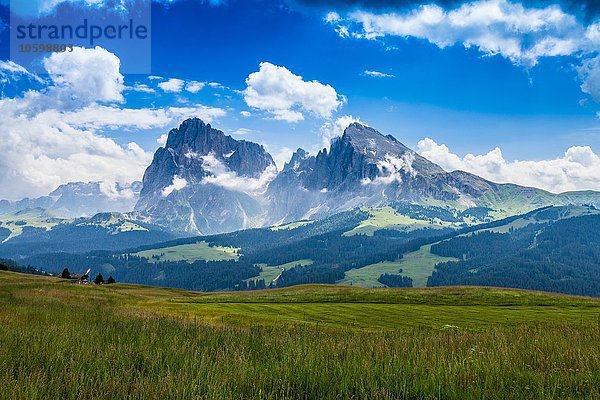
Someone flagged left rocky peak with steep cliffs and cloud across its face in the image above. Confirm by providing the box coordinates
[136,118,275,234]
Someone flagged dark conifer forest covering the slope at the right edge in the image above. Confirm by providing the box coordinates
[428,215,600,296]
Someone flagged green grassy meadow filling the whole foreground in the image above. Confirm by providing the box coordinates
[0,272,600,399]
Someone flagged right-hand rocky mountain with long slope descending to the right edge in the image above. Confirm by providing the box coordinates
[268,123,600,222]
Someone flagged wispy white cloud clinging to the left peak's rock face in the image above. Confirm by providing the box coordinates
[200,154,277,195]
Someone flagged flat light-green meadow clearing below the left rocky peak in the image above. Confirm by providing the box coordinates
[134,242,240,263]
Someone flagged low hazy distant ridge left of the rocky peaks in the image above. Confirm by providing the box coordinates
[0,182,142,218]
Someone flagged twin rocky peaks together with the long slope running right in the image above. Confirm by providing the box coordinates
[134,118,600,234]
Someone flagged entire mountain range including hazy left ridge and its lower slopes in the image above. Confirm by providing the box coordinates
[0,118,600,258]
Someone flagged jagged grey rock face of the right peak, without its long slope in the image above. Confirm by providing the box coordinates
[269,123,468,222]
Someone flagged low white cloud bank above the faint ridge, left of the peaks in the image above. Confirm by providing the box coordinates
[0,95,152,200]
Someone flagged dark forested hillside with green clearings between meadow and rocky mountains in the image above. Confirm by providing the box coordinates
[22,203,600,296]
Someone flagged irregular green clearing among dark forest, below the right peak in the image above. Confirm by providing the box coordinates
[336,245,456,288]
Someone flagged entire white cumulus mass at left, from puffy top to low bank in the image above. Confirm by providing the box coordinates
[0,48,225,200]
